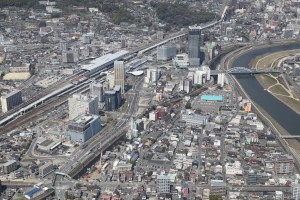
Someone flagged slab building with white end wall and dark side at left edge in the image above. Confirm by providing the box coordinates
[1,90,22,113]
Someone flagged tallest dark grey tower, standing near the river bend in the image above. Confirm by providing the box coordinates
[189,26,201,67]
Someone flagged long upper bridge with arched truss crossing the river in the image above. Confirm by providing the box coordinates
[211,67,281,75]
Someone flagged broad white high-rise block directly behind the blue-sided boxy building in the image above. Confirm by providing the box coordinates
[68,94,99,120]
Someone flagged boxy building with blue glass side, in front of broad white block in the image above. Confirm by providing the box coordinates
[68,114,101,143]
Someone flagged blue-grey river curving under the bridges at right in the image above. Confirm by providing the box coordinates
[232,43,300,135]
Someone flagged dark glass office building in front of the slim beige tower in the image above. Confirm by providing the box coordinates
[104,85,122,111]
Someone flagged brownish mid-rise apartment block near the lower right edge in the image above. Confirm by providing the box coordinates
[274,155,294,174]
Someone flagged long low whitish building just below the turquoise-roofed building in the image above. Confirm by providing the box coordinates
[181,110,208,126]
